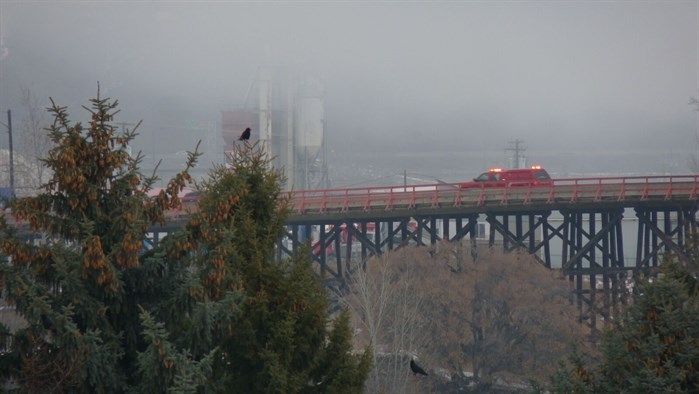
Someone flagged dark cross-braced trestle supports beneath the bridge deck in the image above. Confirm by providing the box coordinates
[280,204,697,332]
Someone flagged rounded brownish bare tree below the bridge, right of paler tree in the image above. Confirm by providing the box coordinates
[431,245,587,382]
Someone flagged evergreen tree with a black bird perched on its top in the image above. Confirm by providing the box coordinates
[143,144,370,393]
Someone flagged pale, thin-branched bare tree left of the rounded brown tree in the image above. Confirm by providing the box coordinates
[344,249,430,393]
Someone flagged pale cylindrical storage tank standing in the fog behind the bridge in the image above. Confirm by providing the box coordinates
[294,78,325,160]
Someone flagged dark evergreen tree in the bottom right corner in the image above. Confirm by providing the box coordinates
[551,255,699,393]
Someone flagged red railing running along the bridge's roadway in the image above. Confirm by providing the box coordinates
[291,175,699,214]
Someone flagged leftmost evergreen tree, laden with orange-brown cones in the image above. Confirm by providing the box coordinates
[0,89,196,393]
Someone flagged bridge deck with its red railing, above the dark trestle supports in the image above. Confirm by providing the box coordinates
[290,175,699,222]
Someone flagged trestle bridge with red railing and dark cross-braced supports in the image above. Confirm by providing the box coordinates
[277,175,699,329]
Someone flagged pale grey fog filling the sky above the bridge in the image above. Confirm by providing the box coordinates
[0,0,699,185]
